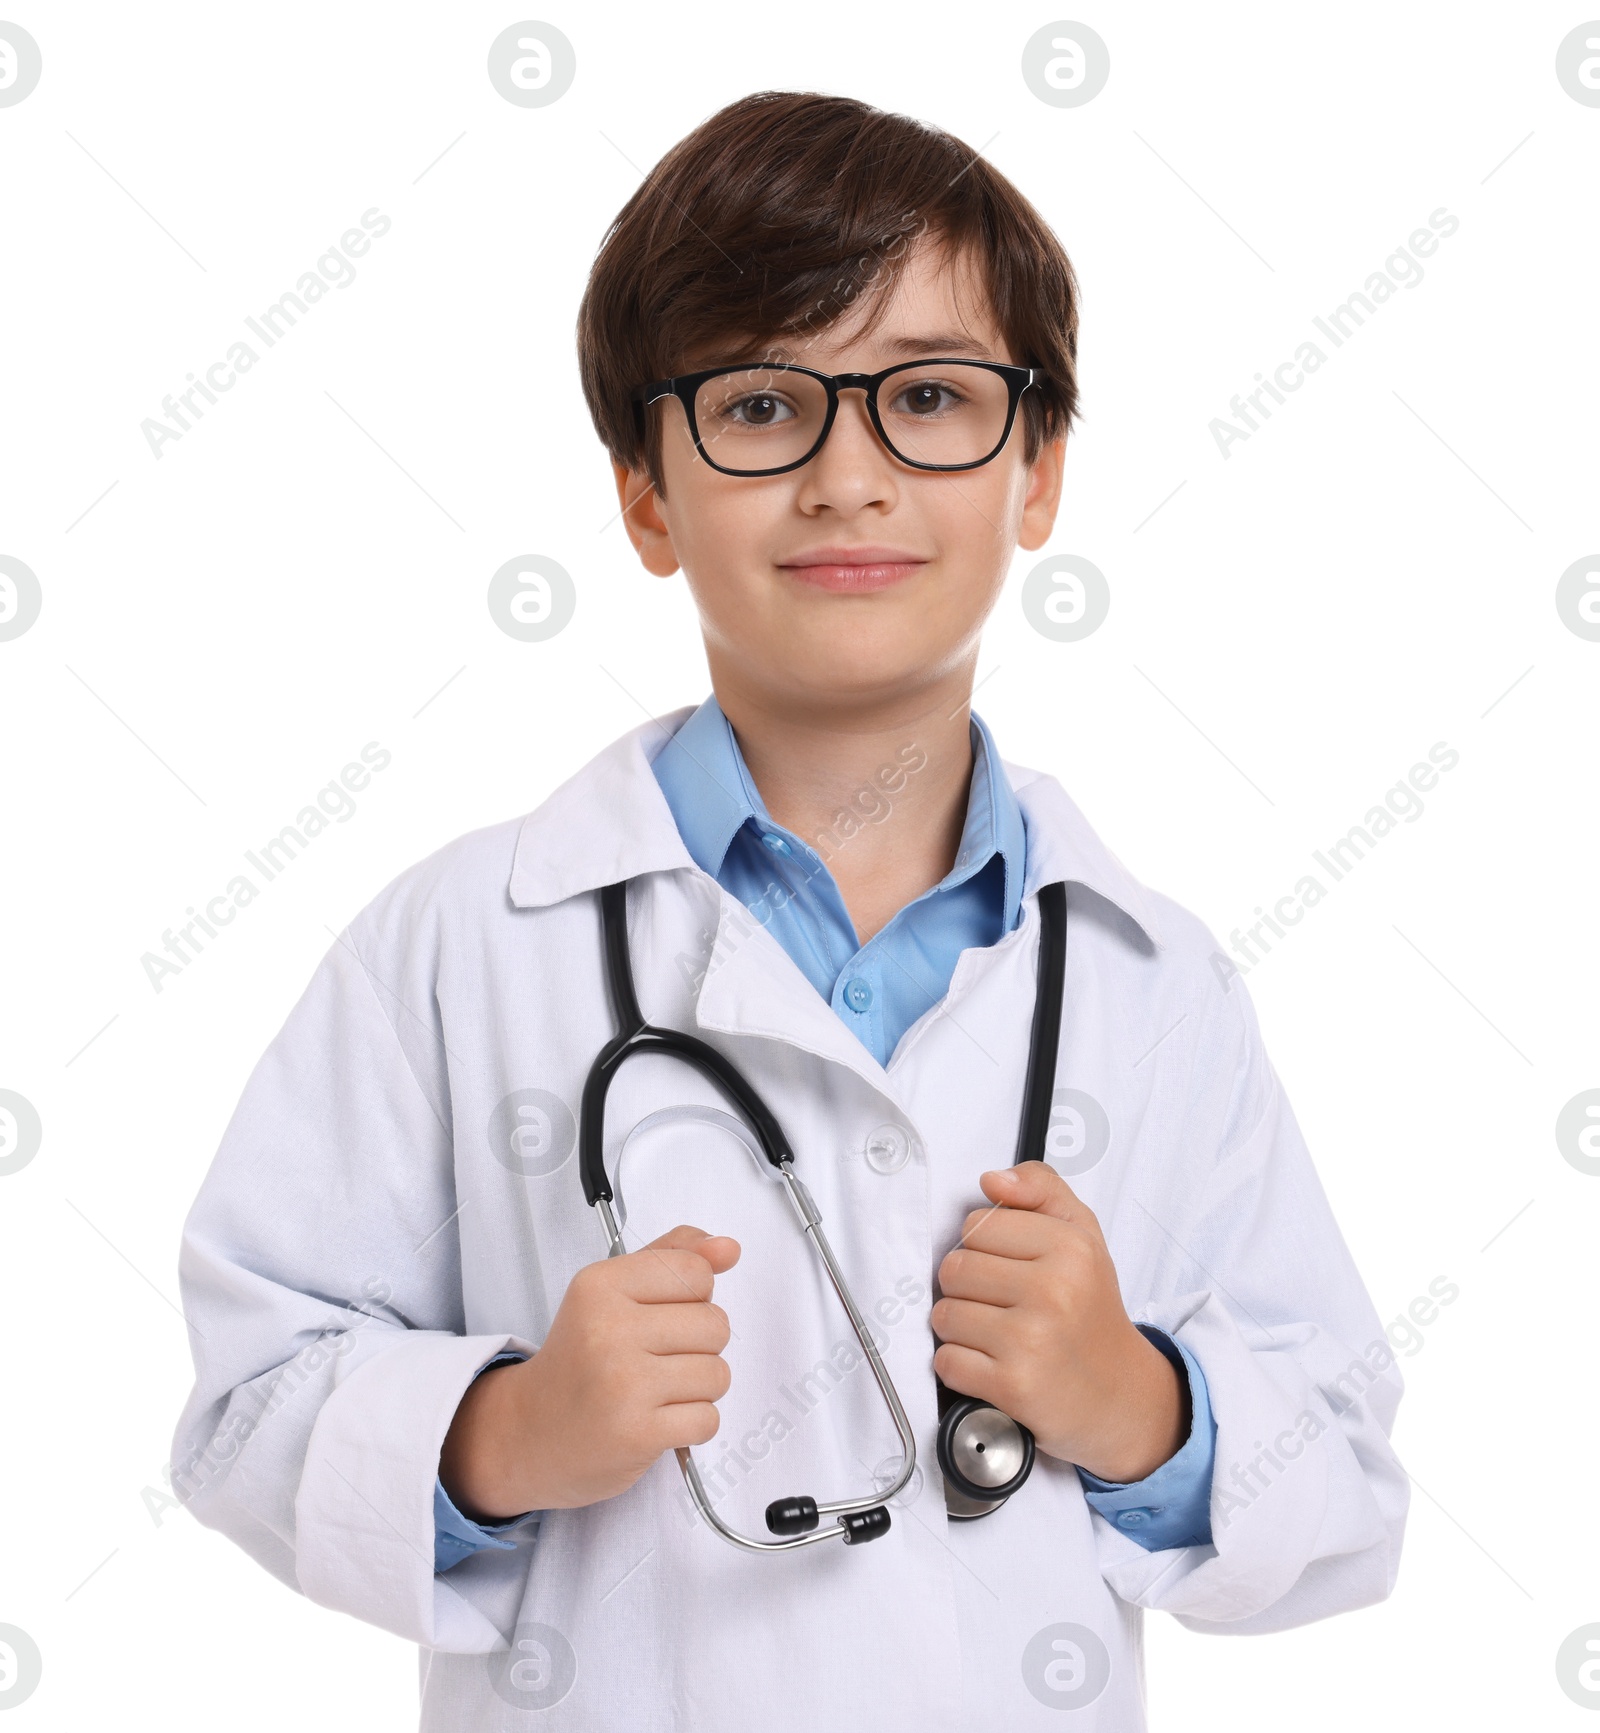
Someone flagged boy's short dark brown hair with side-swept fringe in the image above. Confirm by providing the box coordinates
[577,90,1078,489]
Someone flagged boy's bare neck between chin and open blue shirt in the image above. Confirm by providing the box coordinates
[712,662,972,944]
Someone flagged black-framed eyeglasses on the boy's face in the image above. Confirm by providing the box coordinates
[633,357,1044,475]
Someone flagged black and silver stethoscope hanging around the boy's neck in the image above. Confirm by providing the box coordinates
[577,879,1066,1553]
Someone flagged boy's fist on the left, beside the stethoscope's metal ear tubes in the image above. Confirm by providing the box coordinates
[439,1227,738,1522]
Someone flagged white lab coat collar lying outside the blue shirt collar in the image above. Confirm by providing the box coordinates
[506,700,1163,944]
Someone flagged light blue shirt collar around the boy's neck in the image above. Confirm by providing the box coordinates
[650,695,1026,932]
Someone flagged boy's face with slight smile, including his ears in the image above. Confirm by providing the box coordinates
[617,239,1064,712]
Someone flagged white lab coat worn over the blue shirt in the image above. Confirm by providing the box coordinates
[173,711,1408,1733]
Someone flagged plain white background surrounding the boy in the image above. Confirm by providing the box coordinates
[0,0,1600,1733]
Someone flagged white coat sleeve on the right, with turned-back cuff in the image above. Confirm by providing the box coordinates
[1094,981,1409,1634]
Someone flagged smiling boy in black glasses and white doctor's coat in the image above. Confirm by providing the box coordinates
[175,94,1406,1733]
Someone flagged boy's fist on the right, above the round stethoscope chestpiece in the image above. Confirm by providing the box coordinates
[931,1161,1189,1482]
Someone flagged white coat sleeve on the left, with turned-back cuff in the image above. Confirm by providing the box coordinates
[173,910,536,1650]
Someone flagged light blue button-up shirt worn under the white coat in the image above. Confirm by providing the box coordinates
[433,697,1217,1570]
